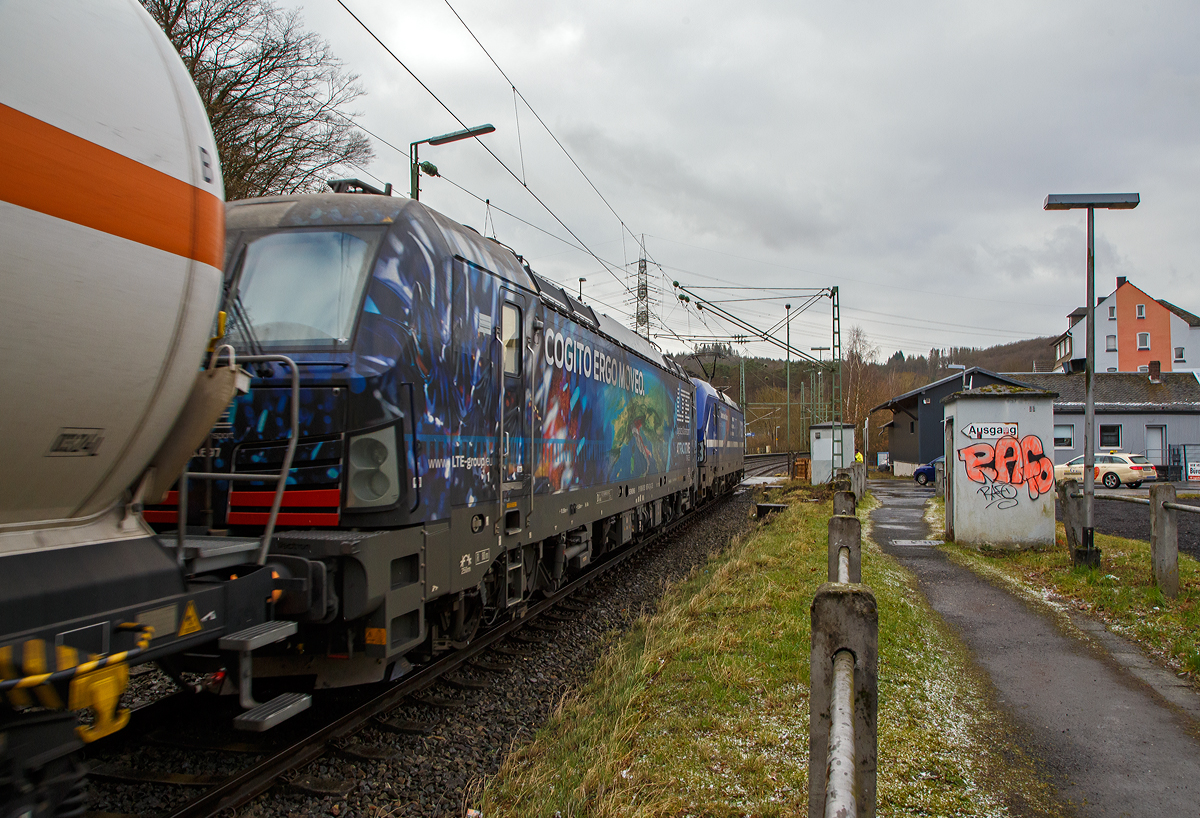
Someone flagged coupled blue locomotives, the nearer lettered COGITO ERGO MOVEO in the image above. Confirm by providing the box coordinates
[148,189,742,687]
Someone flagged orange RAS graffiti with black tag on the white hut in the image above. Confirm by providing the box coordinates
[959,434,1054,509]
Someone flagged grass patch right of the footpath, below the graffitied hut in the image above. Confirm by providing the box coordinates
[928,501,1200,684]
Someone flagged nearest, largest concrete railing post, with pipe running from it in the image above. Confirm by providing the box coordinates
[809,583,880,818]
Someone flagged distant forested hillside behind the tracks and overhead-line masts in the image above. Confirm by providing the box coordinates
[673,326,1054,452]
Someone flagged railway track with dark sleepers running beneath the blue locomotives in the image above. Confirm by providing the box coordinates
[84,486,753,818]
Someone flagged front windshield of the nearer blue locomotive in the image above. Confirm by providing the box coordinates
[230,227,385,349]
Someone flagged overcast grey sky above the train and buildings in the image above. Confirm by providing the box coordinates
[284,0,1200,357]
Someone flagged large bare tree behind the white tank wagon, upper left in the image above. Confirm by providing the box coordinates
[142,0,373,199]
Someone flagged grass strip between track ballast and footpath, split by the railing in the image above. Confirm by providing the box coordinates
[474,487,1057,818]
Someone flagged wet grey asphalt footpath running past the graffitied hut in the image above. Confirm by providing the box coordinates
[869,480,1200,818]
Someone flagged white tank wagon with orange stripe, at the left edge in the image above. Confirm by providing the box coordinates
[0,0,294,816]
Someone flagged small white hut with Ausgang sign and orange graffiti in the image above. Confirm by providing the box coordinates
[942,384,1056,549]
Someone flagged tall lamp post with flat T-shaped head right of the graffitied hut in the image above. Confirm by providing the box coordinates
[1042,193,1141,567]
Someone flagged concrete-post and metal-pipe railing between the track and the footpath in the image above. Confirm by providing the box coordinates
[809,475,878,818]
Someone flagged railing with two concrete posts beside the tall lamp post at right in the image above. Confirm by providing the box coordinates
[1058,480,1200,597]
